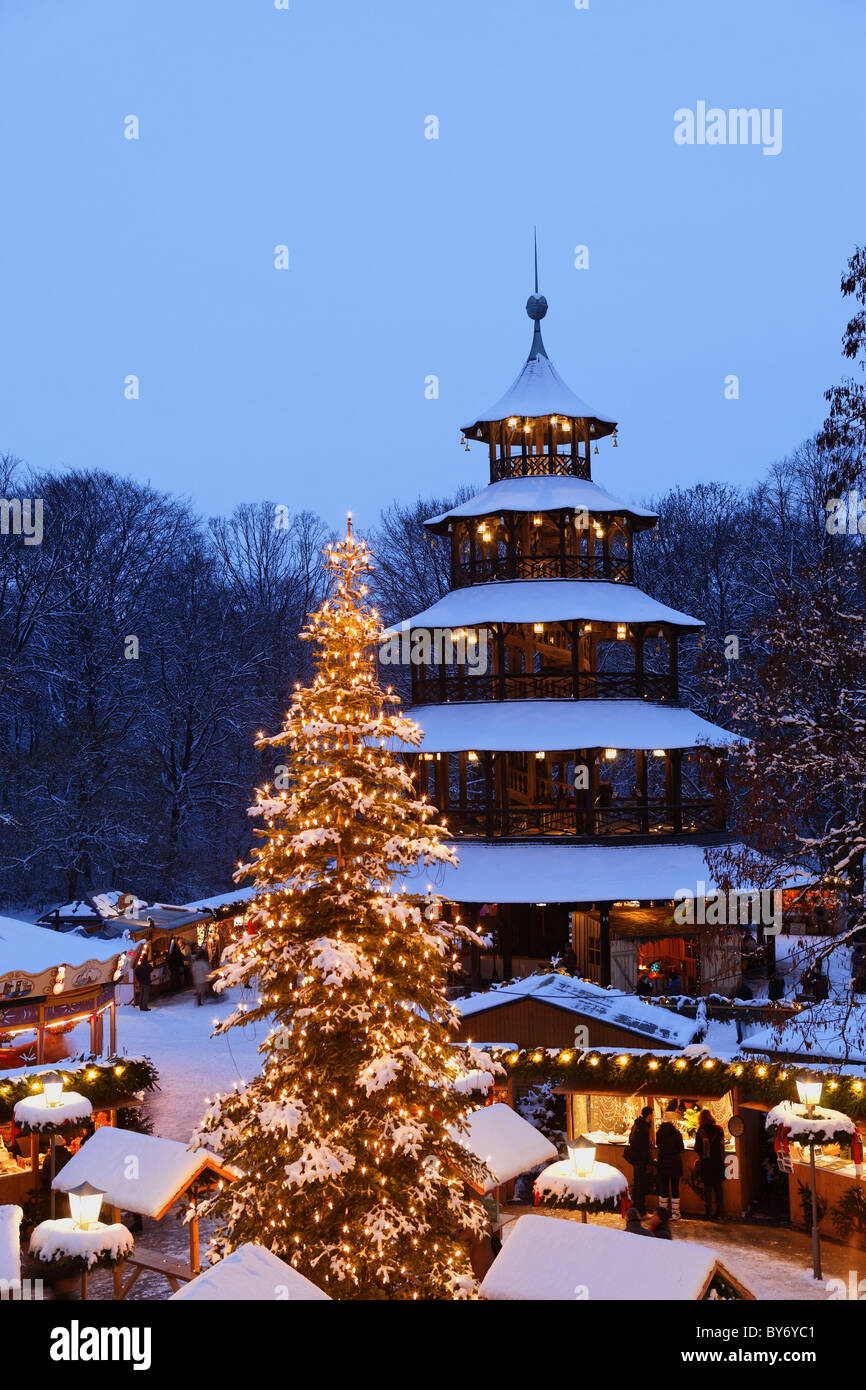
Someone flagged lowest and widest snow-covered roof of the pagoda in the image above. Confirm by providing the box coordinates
[399,841,753,902]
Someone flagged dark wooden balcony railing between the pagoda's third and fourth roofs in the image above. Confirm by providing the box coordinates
[411,667,677,705]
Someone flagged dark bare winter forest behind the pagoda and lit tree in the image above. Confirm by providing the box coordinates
[0,441,865,908]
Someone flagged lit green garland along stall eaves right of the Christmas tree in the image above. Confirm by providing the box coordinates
[488,1048,866,1120]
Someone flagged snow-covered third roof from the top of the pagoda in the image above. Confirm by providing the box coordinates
[389,580,703,632]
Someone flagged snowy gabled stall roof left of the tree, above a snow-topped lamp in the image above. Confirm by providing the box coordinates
[51,1125,235,1220]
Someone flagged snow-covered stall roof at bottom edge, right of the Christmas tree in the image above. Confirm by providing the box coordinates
[481,1216,749,1305]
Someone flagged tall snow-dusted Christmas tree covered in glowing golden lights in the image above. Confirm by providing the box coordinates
[195,531,494,1300]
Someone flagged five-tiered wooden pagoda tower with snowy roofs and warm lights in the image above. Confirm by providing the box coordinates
[402,271,740,992]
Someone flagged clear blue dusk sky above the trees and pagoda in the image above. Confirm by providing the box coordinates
[0,0,866,524]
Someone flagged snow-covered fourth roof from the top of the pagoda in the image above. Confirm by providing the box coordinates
[398,700,738,753]
